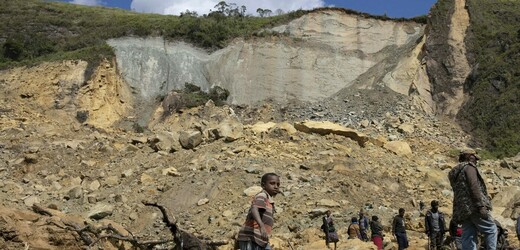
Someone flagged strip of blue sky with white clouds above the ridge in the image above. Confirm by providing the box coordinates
[51,0,437,18]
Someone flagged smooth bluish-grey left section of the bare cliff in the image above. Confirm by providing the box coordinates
[108,38,209,99]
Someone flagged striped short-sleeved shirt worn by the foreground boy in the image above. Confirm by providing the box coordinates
[237,191,274,247]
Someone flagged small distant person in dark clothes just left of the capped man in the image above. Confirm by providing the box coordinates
[424,200,446,250]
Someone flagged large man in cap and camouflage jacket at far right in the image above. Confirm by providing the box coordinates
[448,149,498,250]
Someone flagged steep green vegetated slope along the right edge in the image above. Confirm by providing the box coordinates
[460,0,520,157]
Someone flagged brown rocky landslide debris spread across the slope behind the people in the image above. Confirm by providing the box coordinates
[0,62,520,249]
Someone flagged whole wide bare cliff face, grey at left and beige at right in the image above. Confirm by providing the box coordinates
[109,10,431,112]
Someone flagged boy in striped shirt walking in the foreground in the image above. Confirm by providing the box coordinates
[237,173,280,250]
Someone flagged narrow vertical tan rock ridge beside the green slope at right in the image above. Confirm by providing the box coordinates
[426,0,471,117]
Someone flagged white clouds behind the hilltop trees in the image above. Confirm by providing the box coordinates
[130,0,325,15]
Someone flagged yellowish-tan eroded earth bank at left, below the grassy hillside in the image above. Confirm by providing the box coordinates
[0,61,133,129]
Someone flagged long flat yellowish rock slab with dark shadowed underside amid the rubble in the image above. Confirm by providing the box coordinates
[294,121,369,147]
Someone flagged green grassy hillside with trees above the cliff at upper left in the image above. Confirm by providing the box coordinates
[0,0,425,69]
